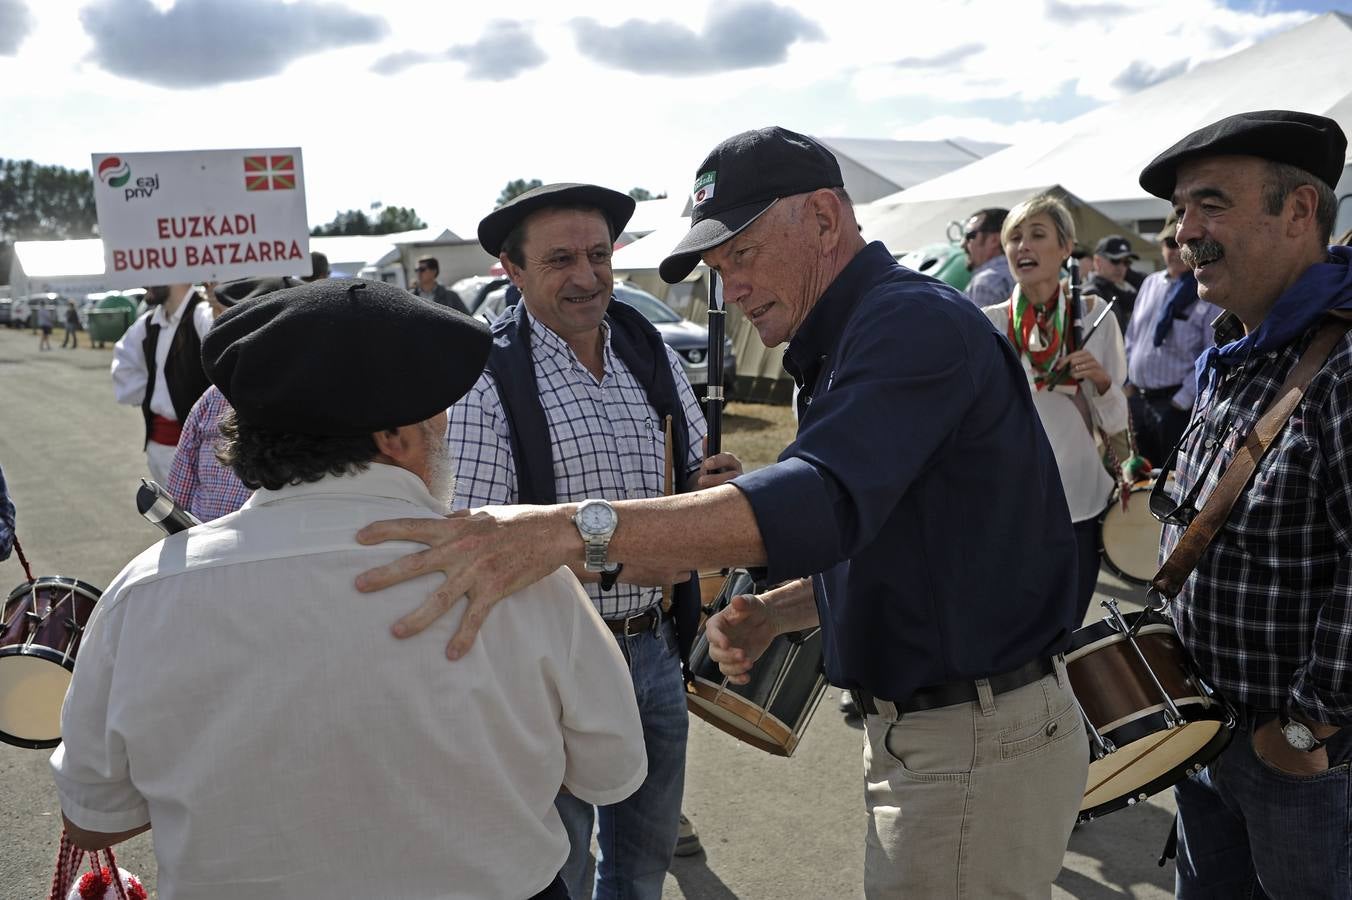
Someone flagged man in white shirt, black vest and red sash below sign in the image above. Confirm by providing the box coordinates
[112,284,212,484]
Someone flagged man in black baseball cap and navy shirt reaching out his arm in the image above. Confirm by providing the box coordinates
[358,128,1088,897]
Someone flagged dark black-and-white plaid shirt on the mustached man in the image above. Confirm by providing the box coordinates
[1161,322,1352,724]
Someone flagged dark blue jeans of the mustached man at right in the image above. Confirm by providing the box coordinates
[1174,714,1352,900]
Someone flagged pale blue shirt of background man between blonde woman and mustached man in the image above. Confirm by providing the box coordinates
[1126,272,1221,409]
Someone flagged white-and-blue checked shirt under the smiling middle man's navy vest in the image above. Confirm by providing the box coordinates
[446,314,704,619]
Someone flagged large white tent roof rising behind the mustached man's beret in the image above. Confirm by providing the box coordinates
[876,12,1352,229]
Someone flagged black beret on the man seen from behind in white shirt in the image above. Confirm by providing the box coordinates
[201,278,491,438]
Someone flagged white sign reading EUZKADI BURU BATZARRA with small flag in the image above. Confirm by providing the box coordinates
[93,147,310,288]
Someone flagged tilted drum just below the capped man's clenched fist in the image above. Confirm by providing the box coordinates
[685,569,826,757]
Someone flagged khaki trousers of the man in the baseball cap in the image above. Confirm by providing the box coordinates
[864,657,1090,900]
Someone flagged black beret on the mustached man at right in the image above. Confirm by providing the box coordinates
[1141,109,1348,200]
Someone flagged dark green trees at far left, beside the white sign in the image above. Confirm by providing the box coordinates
[0,159,99,284]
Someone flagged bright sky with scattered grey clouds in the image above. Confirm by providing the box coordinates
[0,0,1352,235]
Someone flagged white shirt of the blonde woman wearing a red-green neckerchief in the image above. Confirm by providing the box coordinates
[982,297,1130,522]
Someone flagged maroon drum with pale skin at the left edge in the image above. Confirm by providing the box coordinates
[0,576,101,749]
